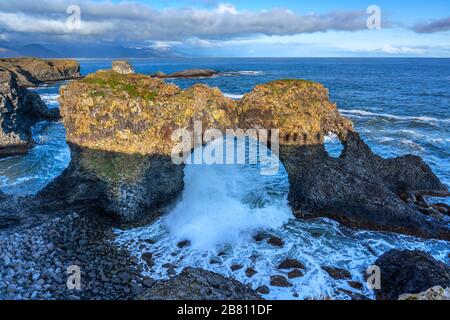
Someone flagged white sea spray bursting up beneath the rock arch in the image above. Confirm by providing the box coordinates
[163,140,292,249]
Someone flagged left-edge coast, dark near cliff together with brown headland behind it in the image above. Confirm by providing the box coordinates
[0,58,80,158]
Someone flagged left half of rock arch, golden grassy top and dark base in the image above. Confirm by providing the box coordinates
[49,71,235,221]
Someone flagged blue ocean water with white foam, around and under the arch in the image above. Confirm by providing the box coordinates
[0,59,450,299]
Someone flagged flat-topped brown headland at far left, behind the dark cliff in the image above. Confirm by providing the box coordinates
[0,58,80,87]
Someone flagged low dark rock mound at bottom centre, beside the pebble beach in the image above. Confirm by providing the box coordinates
[142,268,261,300]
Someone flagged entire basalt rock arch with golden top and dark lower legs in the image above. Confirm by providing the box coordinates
[41,71,450,239]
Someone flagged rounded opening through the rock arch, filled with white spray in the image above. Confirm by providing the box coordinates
[163,135,293,249]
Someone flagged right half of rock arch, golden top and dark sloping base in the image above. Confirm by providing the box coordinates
[239,80,450,239]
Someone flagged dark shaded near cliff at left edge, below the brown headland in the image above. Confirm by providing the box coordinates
[0,67,59,157]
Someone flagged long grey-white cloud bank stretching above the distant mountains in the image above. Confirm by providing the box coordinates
[0,0,367,41]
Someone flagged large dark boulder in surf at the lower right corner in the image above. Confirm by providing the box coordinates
[375,250,450,300]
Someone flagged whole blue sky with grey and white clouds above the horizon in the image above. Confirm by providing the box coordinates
[0,0,450,57]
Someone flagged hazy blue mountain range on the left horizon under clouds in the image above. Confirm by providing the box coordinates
[0,43,181,59]
